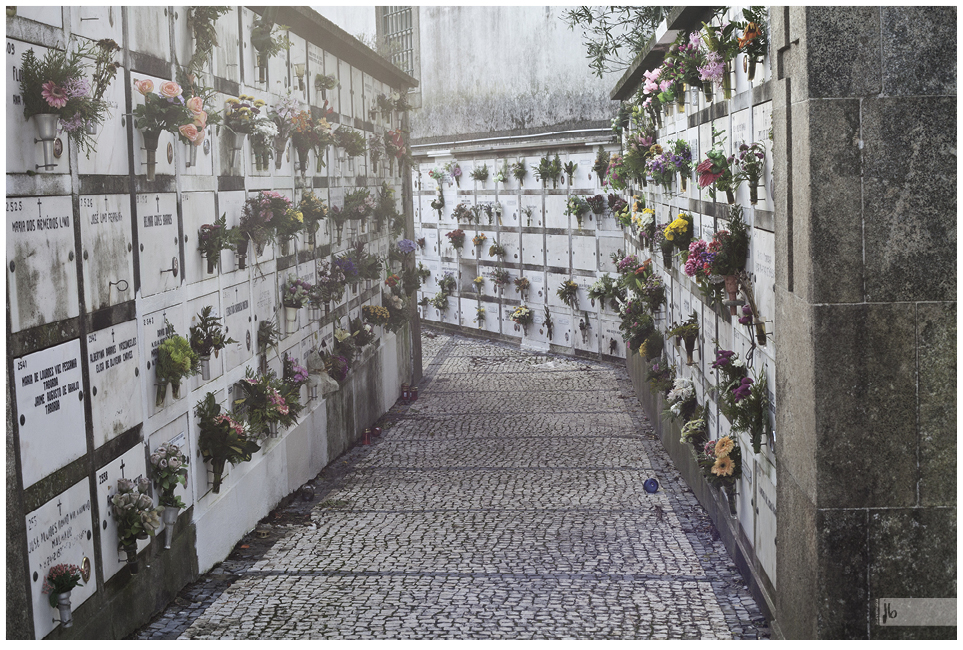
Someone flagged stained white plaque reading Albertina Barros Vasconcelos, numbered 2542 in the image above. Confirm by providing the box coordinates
[87,321,143,447]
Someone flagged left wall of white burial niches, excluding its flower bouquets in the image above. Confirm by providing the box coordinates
[6,6,420,639]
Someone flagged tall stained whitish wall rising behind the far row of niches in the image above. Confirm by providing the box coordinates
[411,6,616,142]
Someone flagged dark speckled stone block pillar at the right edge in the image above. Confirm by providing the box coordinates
[771,7,956,639]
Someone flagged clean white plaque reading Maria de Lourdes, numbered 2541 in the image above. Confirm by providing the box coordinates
[13,339,87,488]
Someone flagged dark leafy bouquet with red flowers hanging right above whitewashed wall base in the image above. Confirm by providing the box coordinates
[194,393,261,494]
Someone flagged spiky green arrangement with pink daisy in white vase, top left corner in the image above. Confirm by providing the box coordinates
[20,39,120,158]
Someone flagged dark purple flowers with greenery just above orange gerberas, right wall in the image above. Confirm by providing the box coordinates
[712,349,769,454]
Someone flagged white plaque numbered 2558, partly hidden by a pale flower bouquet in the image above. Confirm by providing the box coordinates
[97,442,153,580]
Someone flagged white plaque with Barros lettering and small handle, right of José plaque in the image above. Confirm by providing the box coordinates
[137,194,181,296]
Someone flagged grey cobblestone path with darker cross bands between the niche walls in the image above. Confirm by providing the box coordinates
[132,332,769,639]
